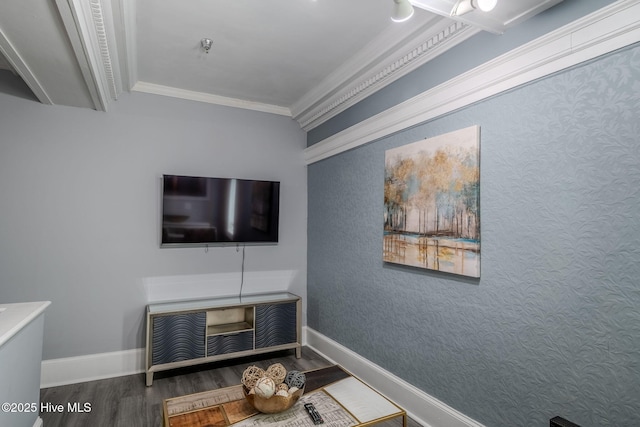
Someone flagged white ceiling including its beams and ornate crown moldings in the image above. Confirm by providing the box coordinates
[0,0,562,130]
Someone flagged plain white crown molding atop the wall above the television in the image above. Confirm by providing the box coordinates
[131,81,291,117]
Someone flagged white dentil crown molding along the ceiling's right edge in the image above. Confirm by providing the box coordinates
[292,15,481,131]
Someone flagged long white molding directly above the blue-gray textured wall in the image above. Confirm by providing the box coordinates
[304,0,640,165]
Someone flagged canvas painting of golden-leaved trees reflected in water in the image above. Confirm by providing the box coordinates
[383,126,480,277]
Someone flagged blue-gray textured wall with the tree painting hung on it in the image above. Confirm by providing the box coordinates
[307,42,640,427]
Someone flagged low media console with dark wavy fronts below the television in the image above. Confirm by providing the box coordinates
[145,292,302,386]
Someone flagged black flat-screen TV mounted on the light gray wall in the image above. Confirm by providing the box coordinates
[161,175,280,246]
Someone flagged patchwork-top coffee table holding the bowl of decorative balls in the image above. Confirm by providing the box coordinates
[162,365,407,427]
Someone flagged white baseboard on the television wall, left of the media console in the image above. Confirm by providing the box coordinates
[40,348,145,388]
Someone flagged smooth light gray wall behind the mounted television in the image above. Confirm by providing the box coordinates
[0,89,307,359]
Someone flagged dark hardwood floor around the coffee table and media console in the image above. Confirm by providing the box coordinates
[40,347,420,427]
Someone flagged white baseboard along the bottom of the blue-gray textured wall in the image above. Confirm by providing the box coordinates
[304,327,484,427]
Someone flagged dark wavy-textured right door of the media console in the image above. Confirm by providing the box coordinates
[256,302,298,348]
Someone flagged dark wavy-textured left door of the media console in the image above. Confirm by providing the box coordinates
[152,312,206,365]
